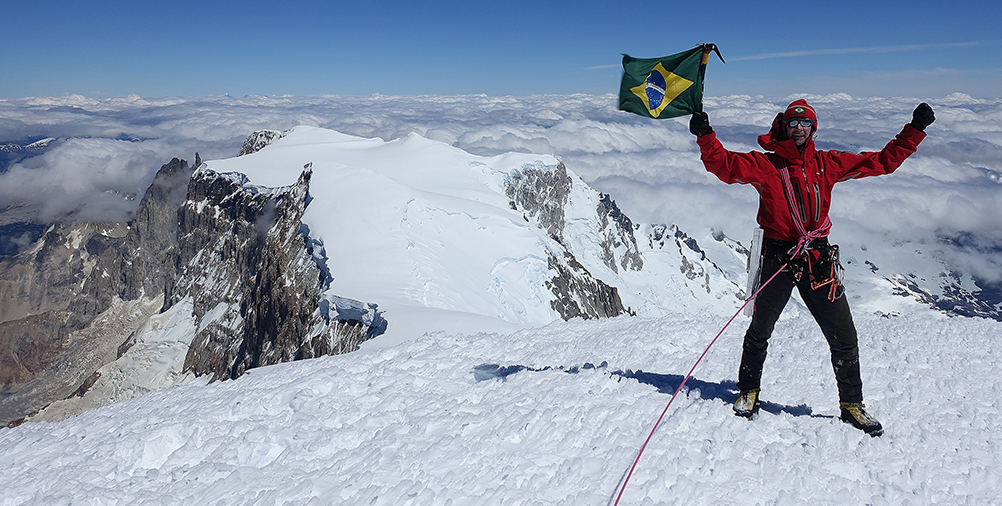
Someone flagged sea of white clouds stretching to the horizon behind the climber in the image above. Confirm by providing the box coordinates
[0,94,1002,282]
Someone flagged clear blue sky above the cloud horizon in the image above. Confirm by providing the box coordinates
[0,0,1002,98]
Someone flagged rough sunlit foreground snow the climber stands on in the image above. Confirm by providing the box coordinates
[0,308,1002,506]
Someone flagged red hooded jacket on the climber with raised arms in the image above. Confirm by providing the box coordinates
[696,117,926,241]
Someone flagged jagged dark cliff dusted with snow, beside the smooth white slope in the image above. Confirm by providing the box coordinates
[164,165,385,379]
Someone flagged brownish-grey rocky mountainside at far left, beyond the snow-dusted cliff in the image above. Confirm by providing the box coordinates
[0,154,197,424]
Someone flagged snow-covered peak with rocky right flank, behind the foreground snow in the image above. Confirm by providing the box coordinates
[205,125,737,342]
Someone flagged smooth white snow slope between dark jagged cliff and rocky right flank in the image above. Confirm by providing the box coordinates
[208,125,577,339]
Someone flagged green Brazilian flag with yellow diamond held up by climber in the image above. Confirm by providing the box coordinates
[619,45,708,119]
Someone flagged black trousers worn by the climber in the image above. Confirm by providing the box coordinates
[737,239,863,403]
